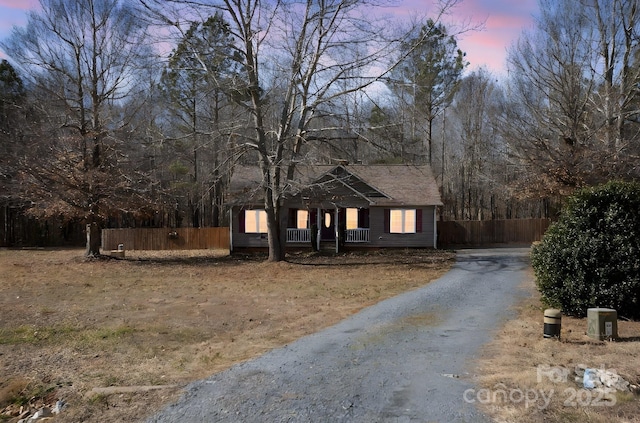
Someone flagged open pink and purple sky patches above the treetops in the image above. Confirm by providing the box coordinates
[0,0,538,75]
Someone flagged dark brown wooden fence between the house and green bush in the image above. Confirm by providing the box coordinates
[438,219,551,247]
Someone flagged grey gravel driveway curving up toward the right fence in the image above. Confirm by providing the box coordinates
[150,249,529,423]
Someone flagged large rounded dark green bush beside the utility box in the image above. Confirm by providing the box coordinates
[531,182,640,319]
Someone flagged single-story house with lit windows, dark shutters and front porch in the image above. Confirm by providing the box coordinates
[230,162,442,251]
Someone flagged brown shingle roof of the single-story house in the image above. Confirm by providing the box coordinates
[230,164,442,206]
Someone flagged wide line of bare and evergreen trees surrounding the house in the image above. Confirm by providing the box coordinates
[0,0,640,260]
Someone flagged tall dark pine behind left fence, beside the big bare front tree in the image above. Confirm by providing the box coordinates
[160,12,239,227]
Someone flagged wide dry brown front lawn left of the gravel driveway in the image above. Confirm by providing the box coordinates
[0,250,454,422]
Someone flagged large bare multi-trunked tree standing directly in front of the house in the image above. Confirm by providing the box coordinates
[141,0,454,261]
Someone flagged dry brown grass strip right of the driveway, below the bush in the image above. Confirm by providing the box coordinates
[470,275,640,423]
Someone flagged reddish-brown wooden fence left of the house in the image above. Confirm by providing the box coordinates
[102,227,229,250]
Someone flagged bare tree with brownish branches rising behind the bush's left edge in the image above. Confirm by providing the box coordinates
[501,2,596,193]
